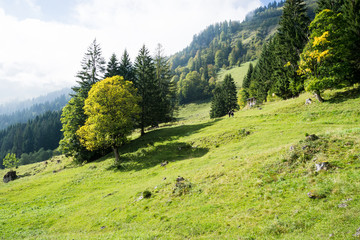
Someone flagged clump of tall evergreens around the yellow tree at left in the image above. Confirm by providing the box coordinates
[60,40,176,162]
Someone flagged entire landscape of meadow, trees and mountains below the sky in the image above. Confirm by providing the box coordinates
[0,0,360,240]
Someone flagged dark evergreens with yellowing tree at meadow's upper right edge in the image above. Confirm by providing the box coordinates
[240,0,360,106]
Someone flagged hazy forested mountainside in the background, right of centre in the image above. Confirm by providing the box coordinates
[170,1,290,104]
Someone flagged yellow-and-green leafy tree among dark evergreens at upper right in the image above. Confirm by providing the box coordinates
[298,9,350,102]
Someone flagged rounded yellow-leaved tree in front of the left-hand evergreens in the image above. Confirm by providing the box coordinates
[77,76,140,162]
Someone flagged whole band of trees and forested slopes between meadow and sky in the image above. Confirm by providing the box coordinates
[0,0,360,169]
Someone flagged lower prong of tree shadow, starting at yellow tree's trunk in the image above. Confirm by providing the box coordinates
[108,142,209,172]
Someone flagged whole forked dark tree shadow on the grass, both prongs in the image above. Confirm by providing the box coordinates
[104,119,220,171]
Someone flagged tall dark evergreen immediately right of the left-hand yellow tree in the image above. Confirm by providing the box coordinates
[134,45,161,135]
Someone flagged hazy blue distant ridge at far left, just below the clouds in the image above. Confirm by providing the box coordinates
[0,94,70,130]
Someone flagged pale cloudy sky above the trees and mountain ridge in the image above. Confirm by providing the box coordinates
[0,0,269,104]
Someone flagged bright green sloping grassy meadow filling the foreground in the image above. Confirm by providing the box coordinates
[0,85,360,239]
